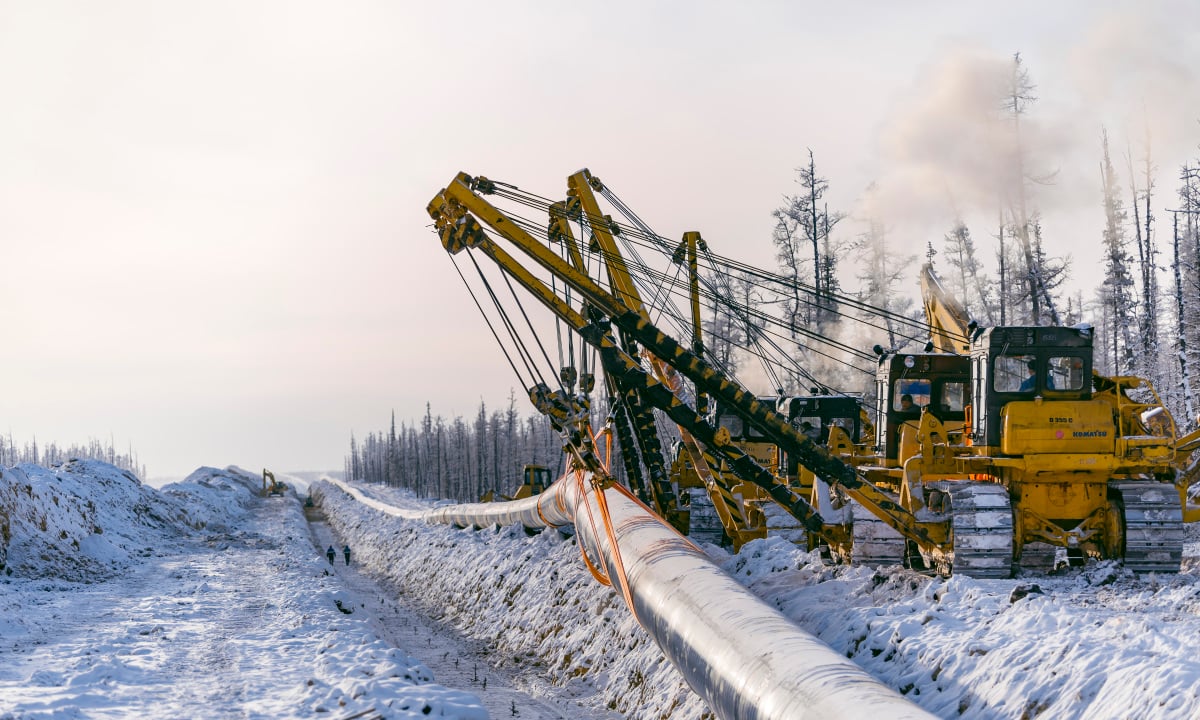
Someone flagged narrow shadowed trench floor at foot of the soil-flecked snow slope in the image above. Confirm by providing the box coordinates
[308,511,622,720]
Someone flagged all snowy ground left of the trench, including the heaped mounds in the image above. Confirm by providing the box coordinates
[0,461,487,720]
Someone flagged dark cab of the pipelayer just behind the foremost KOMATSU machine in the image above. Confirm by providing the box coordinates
[875,353,971,464]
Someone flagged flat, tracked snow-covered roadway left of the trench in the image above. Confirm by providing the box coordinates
[0,463,487,720]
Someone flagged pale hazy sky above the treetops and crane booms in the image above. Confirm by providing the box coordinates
[0,0,1200,476]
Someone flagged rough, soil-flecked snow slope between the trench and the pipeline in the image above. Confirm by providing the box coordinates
[311,482,707,718]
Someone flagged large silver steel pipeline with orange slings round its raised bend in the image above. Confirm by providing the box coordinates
[420,473,934,720]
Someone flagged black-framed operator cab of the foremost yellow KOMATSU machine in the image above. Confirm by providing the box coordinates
[970,326,1105,454]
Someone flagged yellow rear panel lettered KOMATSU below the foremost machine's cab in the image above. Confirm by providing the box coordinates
[1000,401,1116,455]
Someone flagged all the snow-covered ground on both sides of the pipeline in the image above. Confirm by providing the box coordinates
[7,461,1200,720]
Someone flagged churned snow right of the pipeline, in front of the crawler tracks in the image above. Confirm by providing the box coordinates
[725,529,1200,720]
